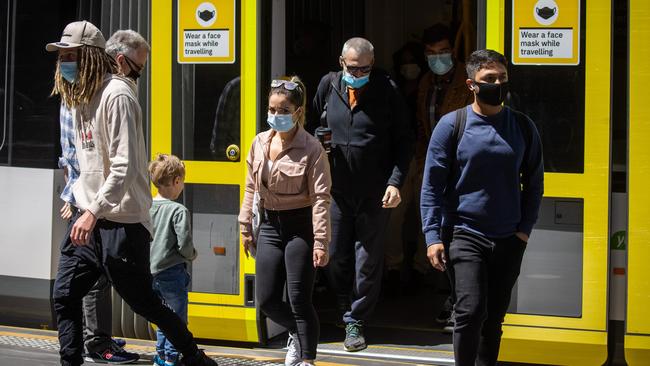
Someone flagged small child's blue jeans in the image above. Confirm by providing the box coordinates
[153,263,190,362]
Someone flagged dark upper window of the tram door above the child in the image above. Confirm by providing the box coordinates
[172,0,241,161]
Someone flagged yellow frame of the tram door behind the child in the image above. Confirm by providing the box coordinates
[150,0,259,342]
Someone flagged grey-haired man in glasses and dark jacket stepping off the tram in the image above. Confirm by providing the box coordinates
[311,38,413,351]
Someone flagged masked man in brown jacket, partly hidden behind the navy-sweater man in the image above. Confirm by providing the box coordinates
[415,23,474,329]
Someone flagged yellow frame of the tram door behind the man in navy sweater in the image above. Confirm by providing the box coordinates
[486,0,612,365]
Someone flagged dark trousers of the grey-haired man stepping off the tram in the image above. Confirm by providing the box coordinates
[327,194,390,323]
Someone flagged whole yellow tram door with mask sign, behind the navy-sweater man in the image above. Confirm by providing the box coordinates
[485,0,608,365]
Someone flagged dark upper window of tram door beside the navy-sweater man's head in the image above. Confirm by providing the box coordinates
[504,0,586,173]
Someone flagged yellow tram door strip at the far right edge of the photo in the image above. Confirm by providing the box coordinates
[624,0,650,365]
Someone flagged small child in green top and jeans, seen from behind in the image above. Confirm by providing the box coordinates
[149,154,196,366]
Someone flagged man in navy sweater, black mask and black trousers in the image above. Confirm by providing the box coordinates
[420,50,544,366]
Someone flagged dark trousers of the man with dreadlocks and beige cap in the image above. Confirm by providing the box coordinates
[53,215,198,365]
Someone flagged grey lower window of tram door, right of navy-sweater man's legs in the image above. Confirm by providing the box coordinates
[508,197,584,317]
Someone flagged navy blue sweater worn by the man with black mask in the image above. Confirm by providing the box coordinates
[420,105,544,245]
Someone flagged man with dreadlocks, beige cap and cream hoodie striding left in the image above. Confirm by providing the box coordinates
[46,21,217,366]
